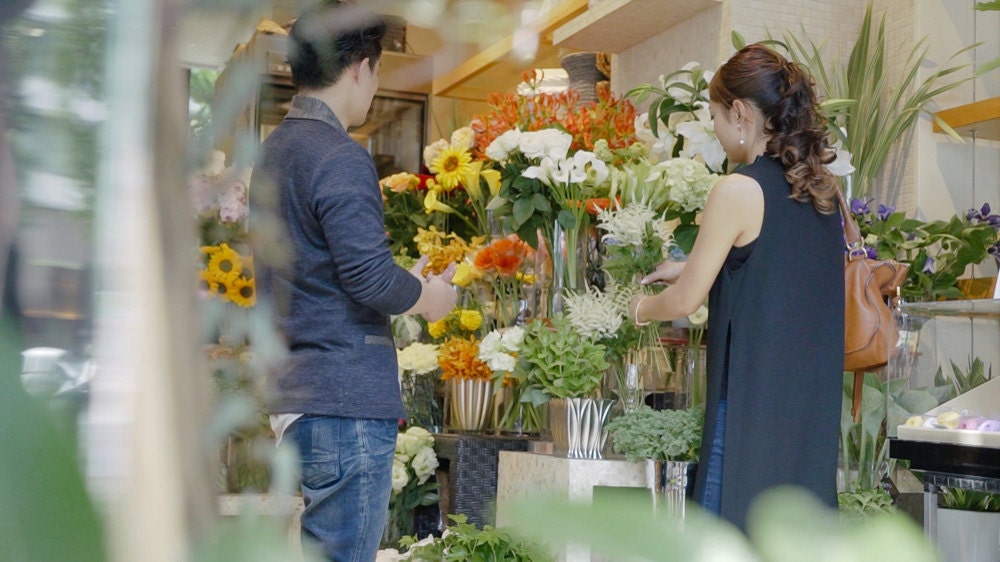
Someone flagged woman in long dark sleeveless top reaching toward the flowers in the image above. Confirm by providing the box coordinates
[629,45,844,530]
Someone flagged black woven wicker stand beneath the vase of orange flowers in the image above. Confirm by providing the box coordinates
[434,433,530,527]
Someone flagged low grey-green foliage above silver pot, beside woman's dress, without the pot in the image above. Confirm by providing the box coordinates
[604,406,705,462]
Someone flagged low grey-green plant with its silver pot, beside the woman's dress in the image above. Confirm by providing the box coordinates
[607,406,705,516]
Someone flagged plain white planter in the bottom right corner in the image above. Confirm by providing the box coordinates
[936,508,1000,562]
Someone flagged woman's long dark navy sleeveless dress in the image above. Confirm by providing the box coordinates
[695,156,844,530]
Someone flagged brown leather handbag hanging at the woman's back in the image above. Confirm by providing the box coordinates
[837,189,910,421]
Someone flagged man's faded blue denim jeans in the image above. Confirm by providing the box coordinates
[284,415,398,562]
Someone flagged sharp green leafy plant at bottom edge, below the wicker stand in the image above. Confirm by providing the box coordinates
[400,515,553,562]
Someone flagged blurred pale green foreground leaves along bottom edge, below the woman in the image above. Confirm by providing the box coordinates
[513,487,937,562]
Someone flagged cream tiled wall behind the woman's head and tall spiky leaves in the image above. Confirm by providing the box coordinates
[611,0,1000,276]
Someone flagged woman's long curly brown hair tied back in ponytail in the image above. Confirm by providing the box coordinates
[709,44,839,214]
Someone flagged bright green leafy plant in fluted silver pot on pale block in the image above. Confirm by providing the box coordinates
[514,313,614,458]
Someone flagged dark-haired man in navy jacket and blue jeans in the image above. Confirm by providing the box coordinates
[251,3,456,562]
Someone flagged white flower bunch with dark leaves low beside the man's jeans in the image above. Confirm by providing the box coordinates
[382,426,440,547]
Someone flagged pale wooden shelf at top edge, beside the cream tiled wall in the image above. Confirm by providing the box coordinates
[552,0,721,53]
